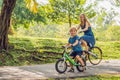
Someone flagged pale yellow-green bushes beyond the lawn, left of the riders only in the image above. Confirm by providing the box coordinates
[16,24,69,38]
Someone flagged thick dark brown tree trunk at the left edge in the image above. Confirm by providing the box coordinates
[0,0,16,50]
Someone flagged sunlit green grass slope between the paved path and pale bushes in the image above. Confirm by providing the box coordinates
[0,36,120,66]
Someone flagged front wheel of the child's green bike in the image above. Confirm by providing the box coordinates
[55,59,67,73]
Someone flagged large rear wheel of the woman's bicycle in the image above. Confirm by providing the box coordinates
[88,46,102,65]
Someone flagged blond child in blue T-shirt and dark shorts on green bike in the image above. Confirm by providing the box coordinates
[65,27,85,72]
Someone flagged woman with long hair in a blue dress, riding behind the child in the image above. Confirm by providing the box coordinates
[77,14,95,51]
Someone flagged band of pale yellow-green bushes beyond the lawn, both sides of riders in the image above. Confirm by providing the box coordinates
[16,24,120,41]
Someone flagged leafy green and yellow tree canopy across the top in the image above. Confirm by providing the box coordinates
[0,0,119,28]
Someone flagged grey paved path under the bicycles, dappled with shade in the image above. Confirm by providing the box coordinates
[0,60,120,80]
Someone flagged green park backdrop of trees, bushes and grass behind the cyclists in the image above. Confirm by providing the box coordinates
[0,0,120,79]
